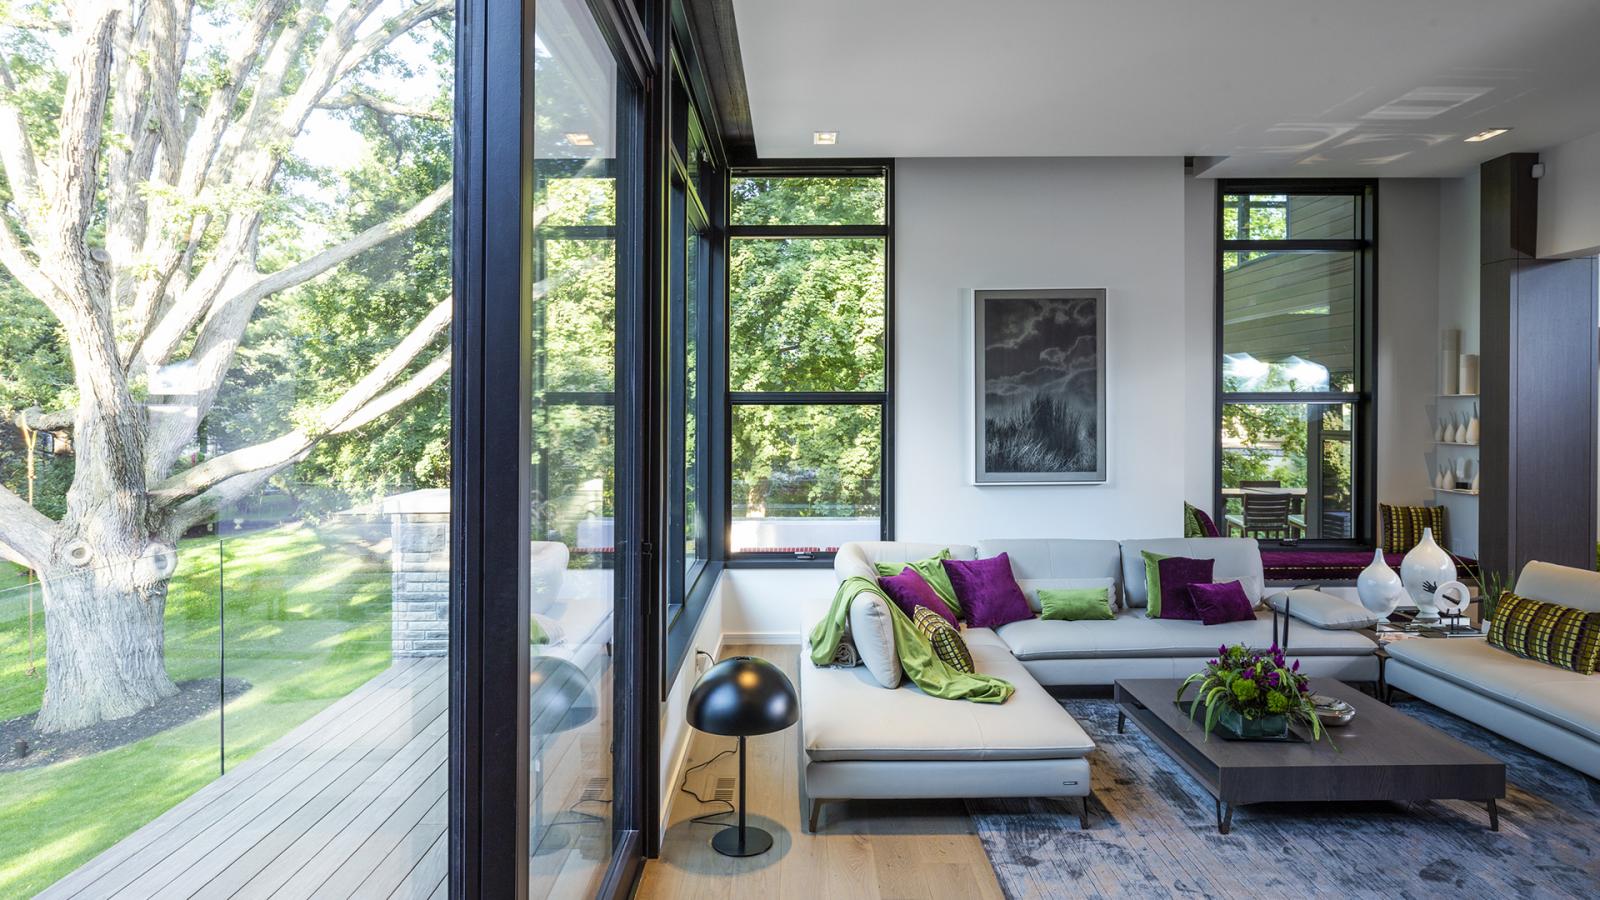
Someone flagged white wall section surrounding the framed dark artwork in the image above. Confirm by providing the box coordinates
[894,159,1187,543]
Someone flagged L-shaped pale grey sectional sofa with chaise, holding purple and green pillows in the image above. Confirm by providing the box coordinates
[800,538,1378,831]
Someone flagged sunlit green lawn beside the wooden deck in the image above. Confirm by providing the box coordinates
[0,525,390,897]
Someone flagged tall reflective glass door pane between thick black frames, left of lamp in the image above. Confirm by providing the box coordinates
[528,0,651,897]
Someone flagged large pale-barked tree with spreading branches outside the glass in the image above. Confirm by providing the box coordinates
[0,0,453,732]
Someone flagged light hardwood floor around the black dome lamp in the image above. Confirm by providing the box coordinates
[637,644,1002,900]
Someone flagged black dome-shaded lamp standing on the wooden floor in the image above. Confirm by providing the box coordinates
[688,657,800,857]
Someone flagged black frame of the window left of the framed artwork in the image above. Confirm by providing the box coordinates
[718,159,894,569]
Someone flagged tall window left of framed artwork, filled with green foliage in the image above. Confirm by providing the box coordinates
[728,165,893,559]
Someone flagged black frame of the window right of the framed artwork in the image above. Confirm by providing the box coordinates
[1211,178,1378,549]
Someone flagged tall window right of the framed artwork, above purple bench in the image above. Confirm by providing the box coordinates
[1218,181,1376,541]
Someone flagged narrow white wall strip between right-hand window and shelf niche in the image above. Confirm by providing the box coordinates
[1376,178,1440,506]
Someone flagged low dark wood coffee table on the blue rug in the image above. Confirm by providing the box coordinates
[1115,679,1506,834]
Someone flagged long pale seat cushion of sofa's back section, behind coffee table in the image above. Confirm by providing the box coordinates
[995,602,1376,660]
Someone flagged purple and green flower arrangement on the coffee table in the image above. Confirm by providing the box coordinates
[1178,644,1323,741]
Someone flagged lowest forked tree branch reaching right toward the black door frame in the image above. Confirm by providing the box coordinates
[150,298,451,509]
